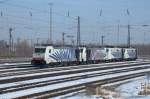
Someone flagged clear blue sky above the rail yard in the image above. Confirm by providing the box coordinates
[0,0,150,44]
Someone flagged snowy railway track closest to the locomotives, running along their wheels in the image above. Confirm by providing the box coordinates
[0,61,150,77]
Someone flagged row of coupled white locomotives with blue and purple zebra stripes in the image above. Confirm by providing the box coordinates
[31,46,137,65]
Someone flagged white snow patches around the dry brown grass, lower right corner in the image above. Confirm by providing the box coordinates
[55,76,150,99]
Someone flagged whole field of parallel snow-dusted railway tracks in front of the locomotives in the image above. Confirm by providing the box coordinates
[0,59,150,99]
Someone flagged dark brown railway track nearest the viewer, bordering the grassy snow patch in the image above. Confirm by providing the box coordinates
[34,73,144,99]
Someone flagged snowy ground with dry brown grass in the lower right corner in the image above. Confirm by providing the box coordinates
[60,76,150,99]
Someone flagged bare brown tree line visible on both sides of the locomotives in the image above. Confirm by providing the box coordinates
[0,40,150,58]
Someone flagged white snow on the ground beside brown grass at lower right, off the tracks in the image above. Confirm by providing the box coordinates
[57,76,150,99]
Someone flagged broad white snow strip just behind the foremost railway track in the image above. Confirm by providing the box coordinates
[0,65,150,99]
